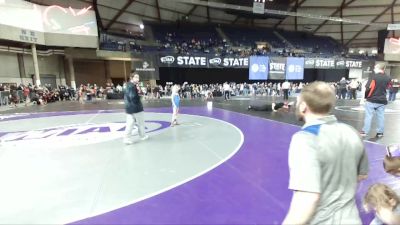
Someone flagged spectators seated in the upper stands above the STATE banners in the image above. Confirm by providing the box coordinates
[100,26,360,58]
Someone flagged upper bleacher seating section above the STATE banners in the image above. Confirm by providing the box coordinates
[100,23,344,57]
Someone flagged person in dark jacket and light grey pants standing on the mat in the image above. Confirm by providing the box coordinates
[124,74,148,144]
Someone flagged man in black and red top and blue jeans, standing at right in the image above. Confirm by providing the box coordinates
[360,63,390,138]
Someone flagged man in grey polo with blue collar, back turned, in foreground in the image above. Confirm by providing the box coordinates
[283,82,368,224]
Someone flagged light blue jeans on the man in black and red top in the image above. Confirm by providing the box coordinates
[362,101,385,134]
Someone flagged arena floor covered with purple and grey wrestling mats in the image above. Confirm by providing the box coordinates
[0,97,400,224]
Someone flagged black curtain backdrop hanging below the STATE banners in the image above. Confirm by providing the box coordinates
[158,67,349,85]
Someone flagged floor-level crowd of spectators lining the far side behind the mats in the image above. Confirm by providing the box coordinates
[0,78,399,107]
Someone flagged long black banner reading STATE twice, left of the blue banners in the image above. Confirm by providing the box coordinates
[158,54,249,68]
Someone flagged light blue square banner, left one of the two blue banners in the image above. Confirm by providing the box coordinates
[249,56,269,80]
